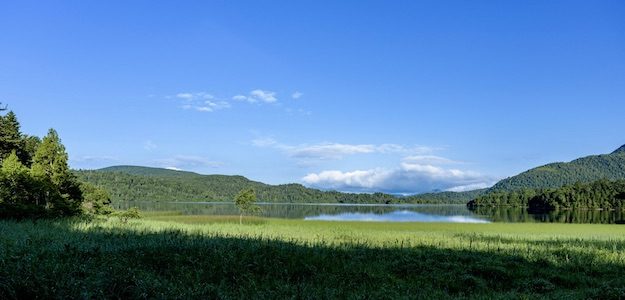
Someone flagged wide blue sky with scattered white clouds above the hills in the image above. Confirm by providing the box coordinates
[0,1,625,193]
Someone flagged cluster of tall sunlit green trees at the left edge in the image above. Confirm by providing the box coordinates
[0,106,110,219]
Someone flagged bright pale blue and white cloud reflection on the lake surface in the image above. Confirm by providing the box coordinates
[304,210,490,223]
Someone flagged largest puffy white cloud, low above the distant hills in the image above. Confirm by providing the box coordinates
[302,157,496,194]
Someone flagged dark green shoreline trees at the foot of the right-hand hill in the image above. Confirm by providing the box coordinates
[467,179,625,212]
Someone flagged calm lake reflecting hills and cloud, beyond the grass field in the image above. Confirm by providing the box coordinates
[114,202,625,224]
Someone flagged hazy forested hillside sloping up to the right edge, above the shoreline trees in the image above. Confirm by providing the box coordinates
[489,145,625,192]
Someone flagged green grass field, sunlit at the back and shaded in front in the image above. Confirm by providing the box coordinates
[0,213,625,299]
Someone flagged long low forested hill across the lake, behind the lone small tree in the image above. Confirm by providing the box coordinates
[75,166,481,204]
